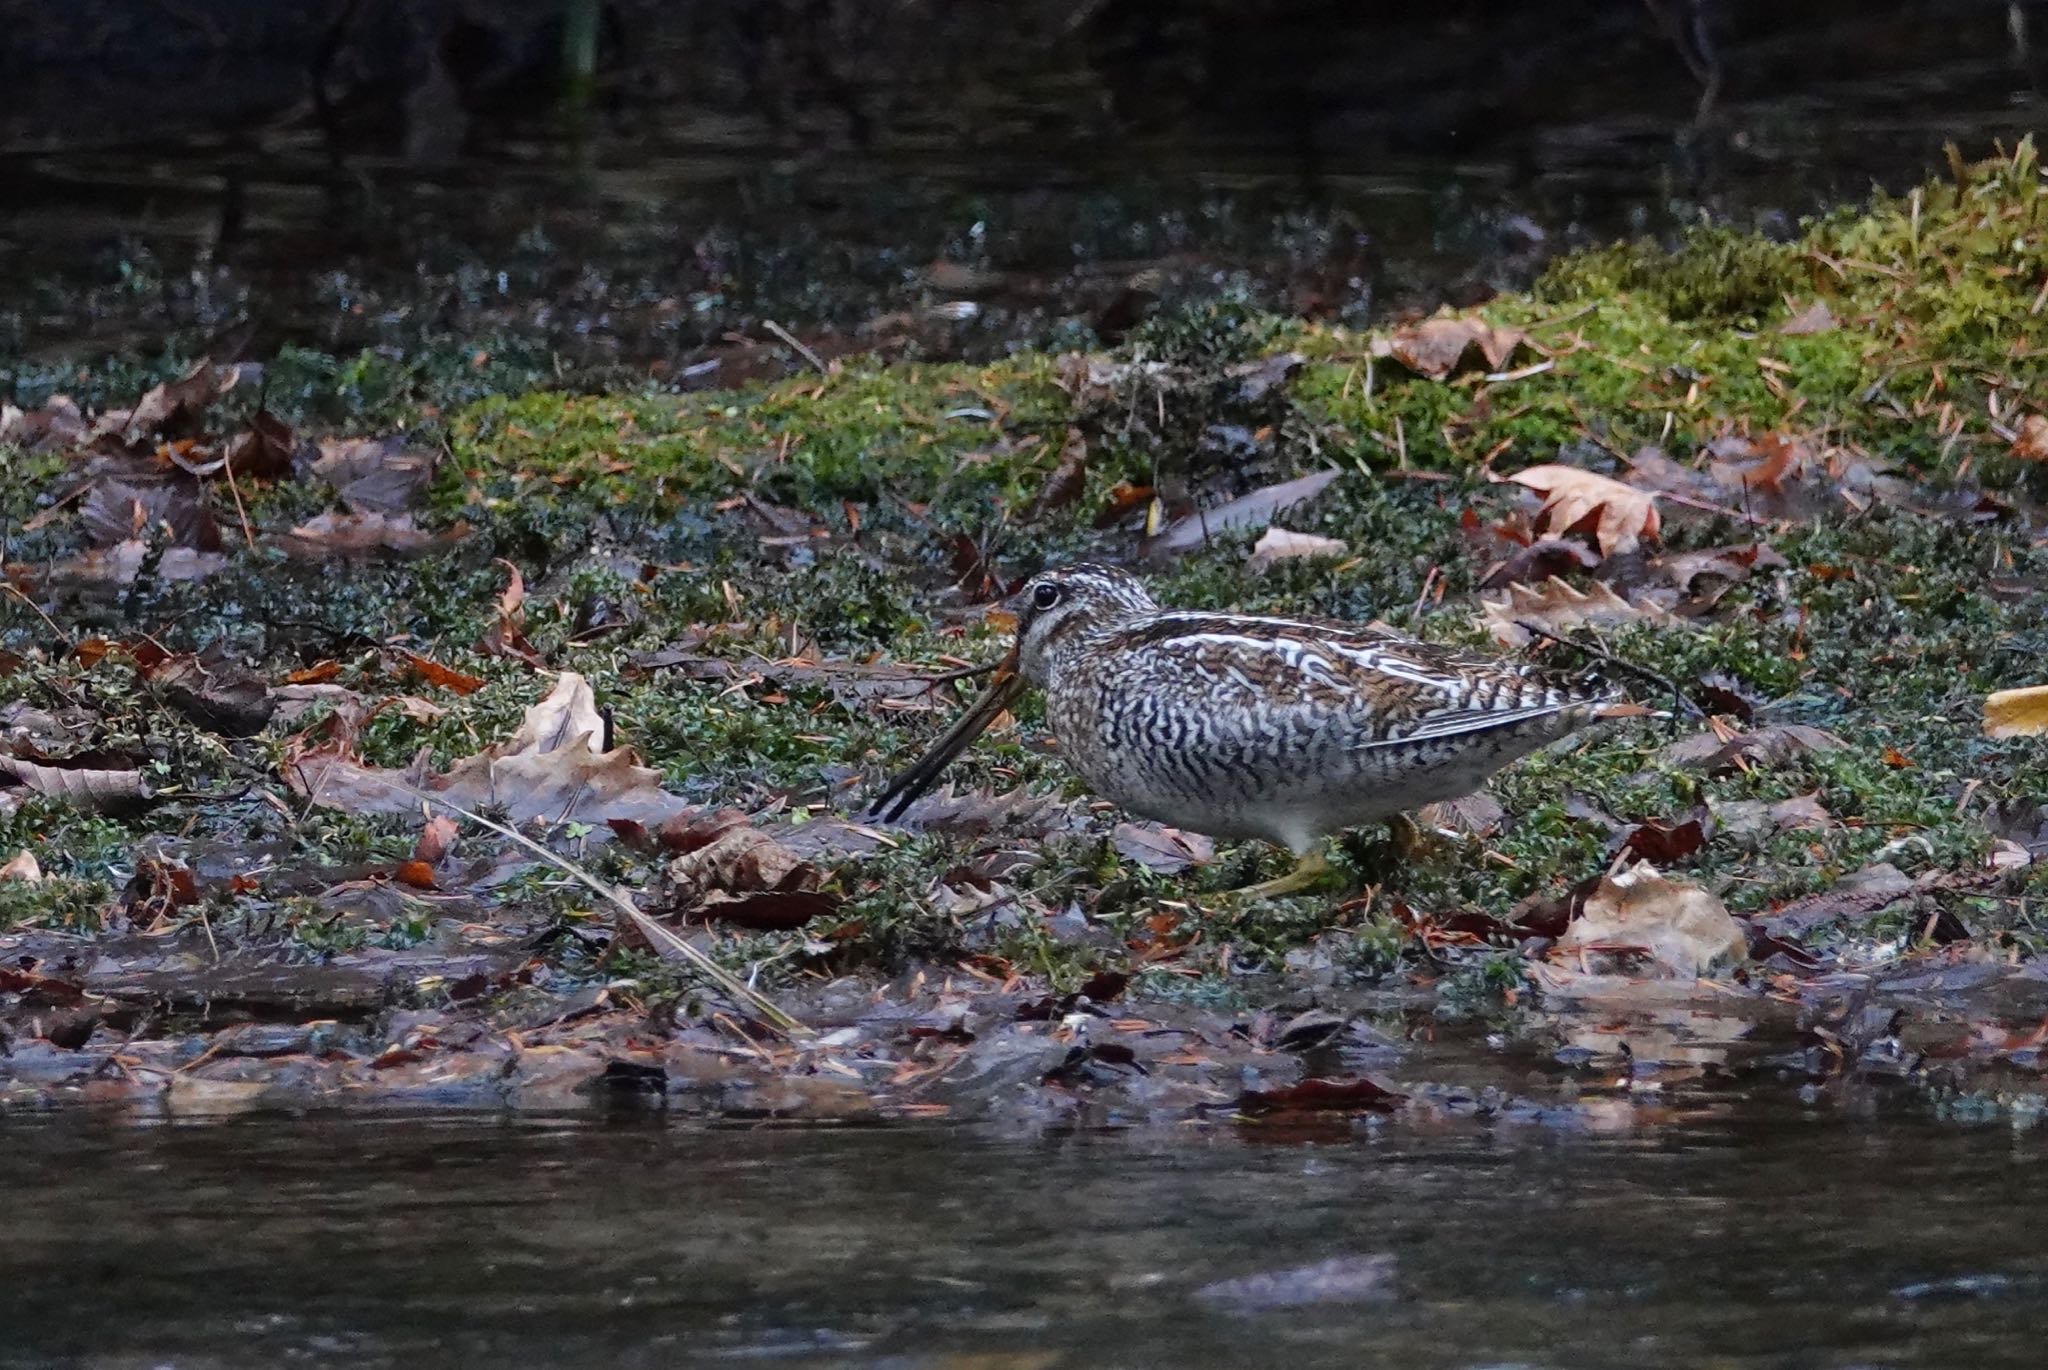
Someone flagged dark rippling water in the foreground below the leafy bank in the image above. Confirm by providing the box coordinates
[0,1108,2048,1370]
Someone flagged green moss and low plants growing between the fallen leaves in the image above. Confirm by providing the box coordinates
[0,147,2048,1005]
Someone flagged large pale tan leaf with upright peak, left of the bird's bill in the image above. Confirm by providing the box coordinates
[285,672,690,825]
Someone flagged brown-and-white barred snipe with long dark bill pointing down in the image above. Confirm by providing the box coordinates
[870,561,1620,899]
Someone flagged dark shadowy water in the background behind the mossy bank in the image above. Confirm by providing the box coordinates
[0,0,2042,374]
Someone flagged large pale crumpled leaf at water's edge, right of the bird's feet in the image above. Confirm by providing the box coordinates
[1550,862,1749,979]
